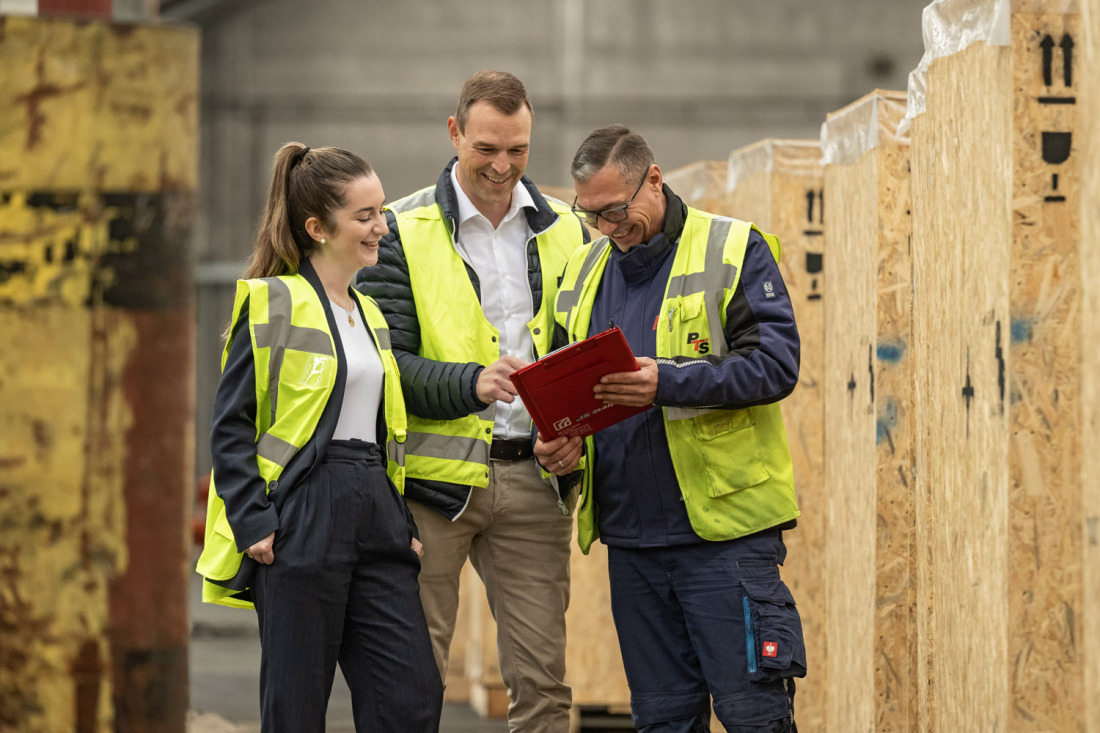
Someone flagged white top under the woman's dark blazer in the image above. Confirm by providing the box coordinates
[329,300,385,442]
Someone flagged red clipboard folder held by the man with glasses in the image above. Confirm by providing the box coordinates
[510,326,649,440]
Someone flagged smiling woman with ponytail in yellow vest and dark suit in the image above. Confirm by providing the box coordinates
[198,143,442,733]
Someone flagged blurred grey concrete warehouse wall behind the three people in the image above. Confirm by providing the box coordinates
[184,0,927,472]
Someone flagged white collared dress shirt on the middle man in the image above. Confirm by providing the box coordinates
[451,166,535,438]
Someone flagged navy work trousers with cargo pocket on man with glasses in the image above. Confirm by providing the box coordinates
[607,529,806,733]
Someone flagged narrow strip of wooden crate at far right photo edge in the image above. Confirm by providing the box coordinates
[1066,0,1100,733]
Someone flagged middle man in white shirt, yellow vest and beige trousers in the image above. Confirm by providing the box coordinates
[359,72,587,733]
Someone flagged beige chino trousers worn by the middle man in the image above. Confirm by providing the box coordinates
[408,459,576,733]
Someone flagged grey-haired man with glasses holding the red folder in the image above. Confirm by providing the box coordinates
[535,125,806,733]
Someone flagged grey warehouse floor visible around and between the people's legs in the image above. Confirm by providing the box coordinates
[190,559,508,733]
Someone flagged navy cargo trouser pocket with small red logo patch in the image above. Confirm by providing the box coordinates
[741,578,806,682]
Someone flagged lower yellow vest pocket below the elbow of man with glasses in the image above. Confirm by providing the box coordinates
[691,409,770,497]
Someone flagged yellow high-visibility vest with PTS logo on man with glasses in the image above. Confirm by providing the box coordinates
[554,207,800,553]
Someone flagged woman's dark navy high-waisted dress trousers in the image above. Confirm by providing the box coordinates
[246,440,443,733]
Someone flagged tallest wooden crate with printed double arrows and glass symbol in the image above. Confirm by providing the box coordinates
[911,2,1097,731]
